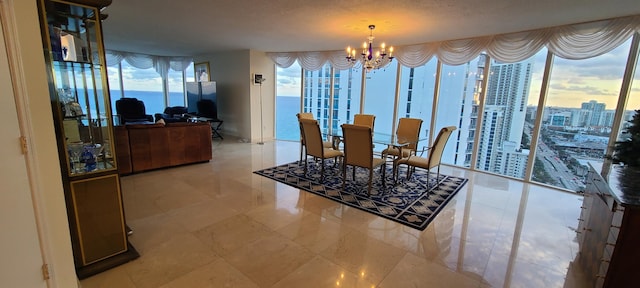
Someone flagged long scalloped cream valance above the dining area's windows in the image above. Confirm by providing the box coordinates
[267,15,640,71]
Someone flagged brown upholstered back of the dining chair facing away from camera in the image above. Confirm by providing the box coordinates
[341,124,373,169]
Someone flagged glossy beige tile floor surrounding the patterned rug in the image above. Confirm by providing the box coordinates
[80,137,585,288]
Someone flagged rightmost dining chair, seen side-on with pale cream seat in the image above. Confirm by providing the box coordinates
[393,126,456,185]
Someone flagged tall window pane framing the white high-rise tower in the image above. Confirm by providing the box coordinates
[474,49,547,179]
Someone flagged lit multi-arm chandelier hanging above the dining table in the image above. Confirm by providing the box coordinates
[346,25,393,72]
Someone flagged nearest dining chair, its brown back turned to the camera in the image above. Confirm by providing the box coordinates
[341,124,385,196]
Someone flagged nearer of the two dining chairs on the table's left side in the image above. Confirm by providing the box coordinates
[300,118,343,178]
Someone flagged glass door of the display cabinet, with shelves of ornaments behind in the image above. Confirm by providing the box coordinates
[45,1,116,176]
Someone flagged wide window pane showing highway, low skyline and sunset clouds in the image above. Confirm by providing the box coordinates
[532,40,631,191]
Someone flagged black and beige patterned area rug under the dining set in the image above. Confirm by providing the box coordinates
[253,160,467,230]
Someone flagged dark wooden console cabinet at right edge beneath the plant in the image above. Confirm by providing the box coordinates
[576,167,640,287]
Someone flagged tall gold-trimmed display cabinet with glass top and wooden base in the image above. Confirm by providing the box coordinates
[39,0,138,279]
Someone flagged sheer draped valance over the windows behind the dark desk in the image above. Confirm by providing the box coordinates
[105,50,193,78]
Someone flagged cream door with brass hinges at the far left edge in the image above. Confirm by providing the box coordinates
[0,8,46,288]
